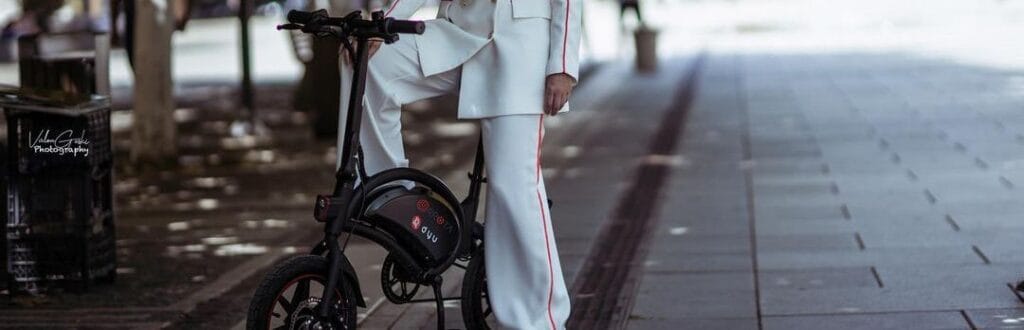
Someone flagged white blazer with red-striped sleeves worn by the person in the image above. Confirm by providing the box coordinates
[385,0,583,119]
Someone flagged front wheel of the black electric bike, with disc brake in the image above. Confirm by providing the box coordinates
[246,255,356,330]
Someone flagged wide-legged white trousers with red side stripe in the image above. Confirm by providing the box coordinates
[339,34,569,329]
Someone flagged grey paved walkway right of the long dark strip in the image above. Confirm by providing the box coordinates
[629,48,1024,329]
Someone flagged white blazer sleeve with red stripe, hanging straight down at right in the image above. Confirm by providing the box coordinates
[548,0,583,79]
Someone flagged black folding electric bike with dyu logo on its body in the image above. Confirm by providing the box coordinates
[247,10,494,330]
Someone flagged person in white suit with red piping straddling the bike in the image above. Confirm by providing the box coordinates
[339,0,582,329]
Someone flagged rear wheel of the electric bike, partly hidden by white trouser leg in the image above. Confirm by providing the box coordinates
[462,248,497,330]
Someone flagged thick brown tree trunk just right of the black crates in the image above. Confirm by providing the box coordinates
[129,0,177,165]
